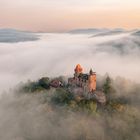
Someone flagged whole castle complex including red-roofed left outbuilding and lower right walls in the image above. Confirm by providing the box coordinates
[43,64,106,104]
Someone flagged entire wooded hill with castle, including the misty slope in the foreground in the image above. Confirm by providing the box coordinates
[3,65,140,140]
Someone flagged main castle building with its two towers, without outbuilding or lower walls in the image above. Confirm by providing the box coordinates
[68,64,96,93]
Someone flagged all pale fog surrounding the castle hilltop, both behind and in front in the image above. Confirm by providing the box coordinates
[0,32,140,140]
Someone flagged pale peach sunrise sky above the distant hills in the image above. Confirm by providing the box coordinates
[0,0,140,32]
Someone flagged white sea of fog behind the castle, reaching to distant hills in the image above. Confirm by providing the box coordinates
[0,33,140,91]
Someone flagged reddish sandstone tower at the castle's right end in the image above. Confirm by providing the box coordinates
[88,69,96,92]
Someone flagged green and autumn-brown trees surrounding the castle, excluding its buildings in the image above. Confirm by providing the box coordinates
[17,75,140,113]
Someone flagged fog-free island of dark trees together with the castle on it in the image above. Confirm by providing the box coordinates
[17,65,131,113]
